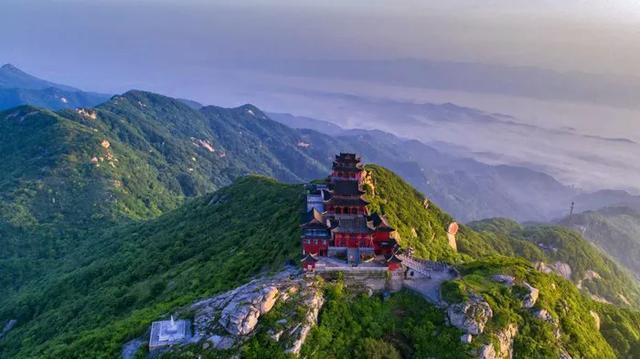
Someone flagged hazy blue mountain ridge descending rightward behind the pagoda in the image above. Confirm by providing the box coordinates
[269,112,640,222]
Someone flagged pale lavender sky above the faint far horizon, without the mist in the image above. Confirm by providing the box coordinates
[0,0,640,92]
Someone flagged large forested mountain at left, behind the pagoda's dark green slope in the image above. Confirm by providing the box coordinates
[0,91,336,291]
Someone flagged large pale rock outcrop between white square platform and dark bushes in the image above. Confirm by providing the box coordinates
[184,268,324,355]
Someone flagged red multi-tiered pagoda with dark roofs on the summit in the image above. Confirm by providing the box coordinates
[302,153,398,269]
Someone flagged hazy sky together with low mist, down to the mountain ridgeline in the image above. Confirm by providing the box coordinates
[0,0,640,192]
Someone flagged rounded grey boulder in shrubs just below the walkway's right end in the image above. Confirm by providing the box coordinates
[447,296,493,335]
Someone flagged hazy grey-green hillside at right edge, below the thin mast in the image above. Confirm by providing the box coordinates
[558,207,640,277]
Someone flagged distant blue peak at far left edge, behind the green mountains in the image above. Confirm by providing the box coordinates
[0,64,110,110]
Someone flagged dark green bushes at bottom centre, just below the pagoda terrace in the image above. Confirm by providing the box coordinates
[301,282,467,359]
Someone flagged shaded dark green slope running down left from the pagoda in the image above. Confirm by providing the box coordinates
[0,177,303,358]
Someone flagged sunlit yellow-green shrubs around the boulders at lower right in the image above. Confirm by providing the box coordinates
[443,257,624,358]
